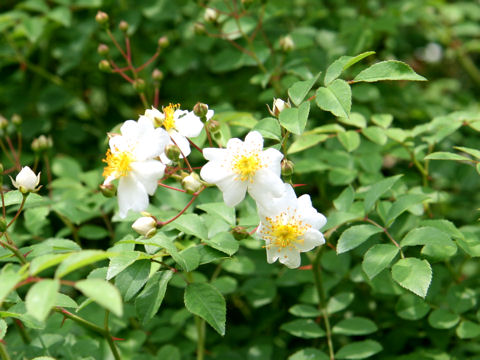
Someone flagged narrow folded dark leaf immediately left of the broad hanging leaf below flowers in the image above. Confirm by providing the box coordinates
[135,270,173,324]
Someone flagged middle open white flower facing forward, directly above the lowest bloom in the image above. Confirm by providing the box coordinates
[200,131,285,206]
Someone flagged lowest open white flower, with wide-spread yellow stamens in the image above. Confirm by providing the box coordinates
[257,184,327,269]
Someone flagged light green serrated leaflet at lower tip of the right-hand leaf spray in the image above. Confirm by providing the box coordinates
[392,258,432,298]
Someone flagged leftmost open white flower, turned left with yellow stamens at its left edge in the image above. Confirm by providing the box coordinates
[103,118,169,218]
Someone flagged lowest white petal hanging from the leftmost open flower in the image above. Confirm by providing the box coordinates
[117,175,148,218]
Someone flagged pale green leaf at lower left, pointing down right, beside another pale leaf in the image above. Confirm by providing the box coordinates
[75,279,123,316]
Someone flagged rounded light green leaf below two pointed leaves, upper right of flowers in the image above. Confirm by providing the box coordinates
[315,79,352,118]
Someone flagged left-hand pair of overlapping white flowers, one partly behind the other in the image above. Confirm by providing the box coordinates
[103,104,207,218]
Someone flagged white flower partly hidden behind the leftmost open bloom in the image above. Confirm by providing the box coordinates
[140,104,206,165]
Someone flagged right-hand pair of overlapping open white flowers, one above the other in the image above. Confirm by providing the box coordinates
[200,131,326,268]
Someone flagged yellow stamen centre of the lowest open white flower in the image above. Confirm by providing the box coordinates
[261,209,311,251]
